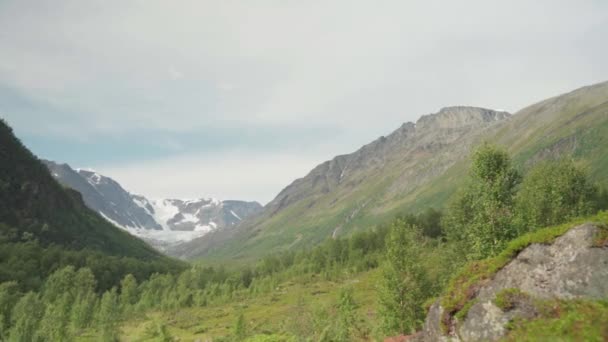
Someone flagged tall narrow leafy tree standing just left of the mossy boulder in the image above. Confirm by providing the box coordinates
[379,220,429,334]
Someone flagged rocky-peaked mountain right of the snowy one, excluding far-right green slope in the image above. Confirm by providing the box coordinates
[171,106,511,258]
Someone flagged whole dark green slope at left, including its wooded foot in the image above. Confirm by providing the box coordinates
[0,120,184,289]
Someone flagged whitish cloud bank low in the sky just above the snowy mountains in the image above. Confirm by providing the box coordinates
[93,151,324,204]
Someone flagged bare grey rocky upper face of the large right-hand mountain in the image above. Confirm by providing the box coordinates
[265,106,511,214]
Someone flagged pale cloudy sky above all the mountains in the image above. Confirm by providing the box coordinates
[0,0,608,203]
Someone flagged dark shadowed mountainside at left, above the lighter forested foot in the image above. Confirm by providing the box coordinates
[0,120,166,258]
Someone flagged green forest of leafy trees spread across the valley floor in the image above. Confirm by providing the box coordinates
[0,144,608,341]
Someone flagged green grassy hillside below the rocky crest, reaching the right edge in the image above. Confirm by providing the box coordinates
[192,82,608,260]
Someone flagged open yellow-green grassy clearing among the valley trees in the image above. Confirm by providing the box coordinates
[78,270,380,341]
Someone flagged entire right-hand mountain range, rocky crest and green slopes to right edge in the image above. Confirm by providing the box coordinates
[170,82,608,258]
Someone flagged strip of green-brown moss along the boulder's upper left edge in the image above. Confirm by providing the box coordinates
[441,211,608,333]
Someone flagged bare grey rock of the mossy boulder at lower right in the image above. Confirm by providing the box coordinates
[418,223,608,341]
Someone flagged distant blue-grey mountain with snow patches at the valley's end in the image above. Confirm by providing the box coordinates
[43,160,262,249]
